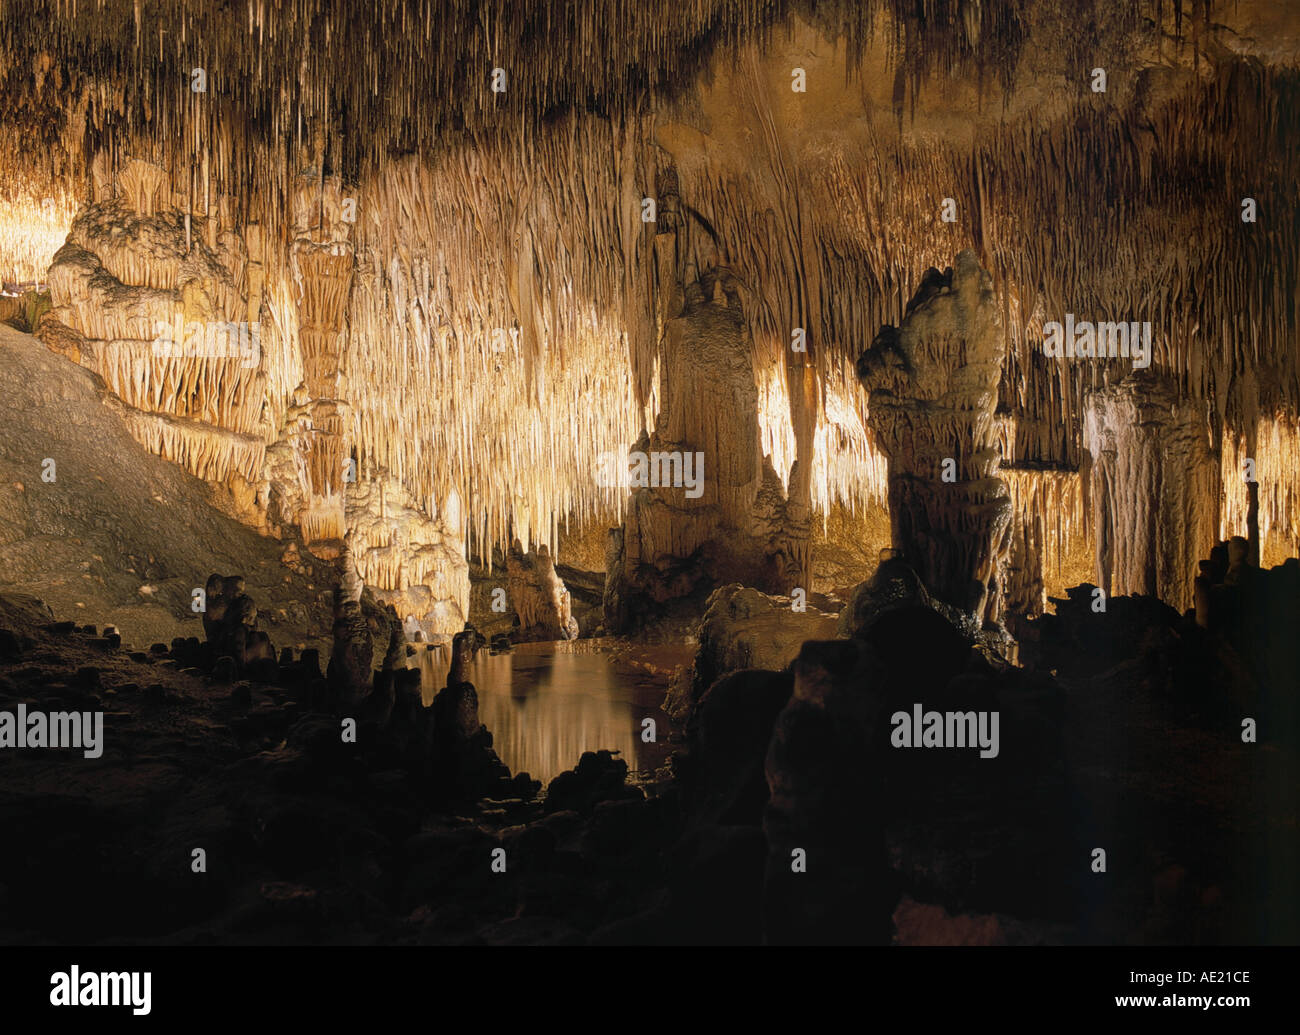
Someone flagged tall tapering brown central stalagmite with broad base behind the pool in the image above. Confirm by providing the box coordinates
[606,174,811,629]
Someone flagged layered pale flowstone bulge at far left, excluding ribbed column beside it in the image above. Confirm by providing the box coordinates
[38,161,268,509]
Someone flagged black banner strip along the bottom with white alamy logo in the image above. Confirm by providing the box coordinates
[0,947,1292,1030]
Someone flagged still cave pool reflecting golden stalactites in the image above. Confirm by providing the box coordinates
[408,641,671,784]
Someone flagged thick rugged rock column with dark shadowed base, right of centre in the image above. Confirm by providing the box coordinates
[858,251,1011,632]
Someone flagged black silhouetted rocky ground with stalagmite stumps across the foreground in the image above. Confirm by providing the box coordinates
[0,546,1300,944]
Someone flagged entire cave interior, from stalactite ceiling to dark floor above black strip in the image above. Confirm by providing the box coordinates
[0,0,1300,944]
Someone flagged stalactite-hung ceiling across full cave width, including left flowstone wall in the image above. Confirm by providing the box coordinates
[0,0,1300,613]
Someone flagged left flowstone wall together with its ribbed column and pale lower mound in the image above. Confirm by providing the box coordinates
[39,161,469,640]
